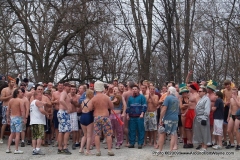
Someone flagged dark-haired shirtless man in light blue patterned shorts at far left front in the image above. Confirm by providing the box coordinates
[6,89,27,154]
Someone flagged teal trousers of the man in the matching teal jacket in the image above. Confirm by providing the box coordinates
[128,117,145,145]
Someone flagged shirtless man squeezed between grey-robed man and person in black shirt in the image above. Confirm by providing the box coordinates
[207,85,217,146]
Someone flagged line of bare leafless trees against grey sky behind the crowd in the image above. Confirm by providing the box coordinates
[0,0,240,86]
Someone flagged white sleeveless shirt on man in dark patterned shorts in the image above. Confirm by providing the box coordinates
[30,100,46,125]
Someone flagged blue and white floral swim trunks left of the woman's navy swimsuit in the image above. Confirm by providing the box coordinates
[57,110,71,132]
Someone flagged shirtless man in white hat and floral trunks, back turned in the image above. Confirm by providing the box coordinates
[88,81,114,156]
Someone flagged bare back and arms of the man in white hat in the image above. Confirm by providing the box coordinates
[88,93,113,117]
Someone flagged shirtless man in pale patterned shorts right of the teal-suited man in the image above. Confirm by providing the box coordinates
[144,86,158,147]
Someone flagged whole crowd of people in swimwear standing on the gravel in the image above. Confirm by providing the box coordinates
[0,74,240,156]
